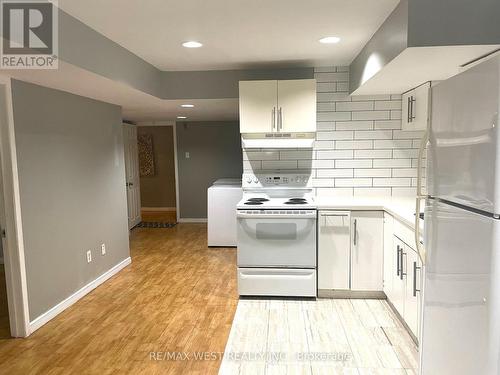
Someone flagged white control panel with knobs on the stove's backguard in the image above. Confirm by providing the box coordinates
[243,173,312,188]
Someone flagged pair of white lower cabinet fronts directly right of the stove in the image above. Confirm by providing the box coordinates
[318,211,384,292]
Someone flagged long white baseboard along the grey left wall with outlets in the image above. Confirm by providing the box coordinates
[29,257,132,335]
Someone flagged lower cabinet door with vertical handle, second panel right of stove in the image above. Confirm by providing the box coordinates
[351,211,384,291]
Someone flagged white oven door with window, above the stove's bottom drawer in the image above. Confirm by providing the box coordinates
[237,212,316,268]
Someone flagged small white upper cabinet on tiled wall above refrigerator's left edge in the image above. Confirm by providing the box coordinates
[401,82,431,130]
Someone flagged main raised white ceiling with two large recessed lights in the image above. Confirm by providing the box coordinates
[59,0,399,71]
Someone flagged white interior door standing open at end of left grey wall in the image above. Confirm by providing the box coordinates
[123,124,141,229]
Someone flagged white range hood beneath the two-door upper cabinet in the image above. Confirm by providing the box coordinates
[241,132,316,148]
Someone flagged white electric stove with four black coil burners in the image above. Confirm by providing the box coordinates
[237,173,317,297]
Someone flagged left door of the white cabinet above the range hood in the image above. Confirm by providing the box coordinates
[239,80,278,133]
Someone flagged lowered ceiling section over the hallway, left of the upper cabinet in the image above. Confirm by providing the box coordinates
[0,61,238,121]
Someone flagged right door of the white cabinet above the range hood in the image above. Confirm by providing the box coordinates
[278,79,316,133]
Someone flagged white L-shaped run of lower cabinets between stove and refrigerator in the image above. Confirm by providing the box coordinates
[318,210,422,344]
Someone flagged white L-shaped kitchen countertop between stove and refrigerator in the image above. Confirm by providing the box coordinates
[315,196,423,230]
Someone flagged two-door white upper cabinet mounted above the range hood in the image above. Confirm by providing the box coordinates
[239,79,316,133]
